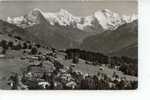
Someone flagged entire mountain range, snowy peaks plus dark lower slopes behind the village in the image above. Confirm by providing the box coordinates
[0,8,138,56]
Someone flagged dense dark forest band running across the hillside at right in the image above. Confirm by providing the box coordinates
[66,49,138,76]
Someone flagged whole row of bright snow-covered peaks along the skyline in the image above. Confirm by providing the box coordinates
[7,8,137,30]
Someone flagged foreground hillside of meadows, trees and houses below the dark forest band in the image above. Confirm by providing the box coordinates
[0,34,137,90]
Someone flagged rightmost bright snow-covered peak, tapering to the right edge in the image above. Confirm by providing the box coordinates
[94,9,137,30]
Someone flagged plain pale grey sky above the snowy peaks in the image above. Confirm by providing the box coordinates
[0,0,137,19]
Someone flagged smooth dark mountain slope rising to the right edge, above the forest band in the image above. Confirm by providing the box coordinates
[81,20,138,58]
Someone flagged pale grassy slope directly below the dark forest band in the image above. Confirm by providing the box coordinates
[58,52,137,80]
